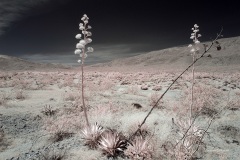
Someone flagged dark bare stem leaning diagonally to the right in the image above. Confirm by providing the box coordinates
[129,28,223,139]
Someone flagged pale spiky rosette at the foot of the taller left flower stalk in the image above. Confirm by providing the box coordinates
[82,123,104,148]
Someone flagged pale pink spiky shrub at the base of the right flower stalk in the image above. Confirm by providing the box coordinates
[163,118,206,160]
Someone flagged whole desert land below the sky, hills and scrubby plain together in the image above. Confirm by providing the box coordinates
[0,34,240,160]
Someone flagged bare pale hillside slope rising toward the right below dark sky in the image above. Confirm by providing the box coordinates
[91,37,240,70]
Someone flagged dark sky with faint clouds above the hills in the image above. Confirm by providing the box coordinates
[0,0,240,64]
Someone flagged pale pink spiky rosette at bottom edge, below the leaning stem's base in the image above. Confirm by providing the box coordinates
[124,137,153,160]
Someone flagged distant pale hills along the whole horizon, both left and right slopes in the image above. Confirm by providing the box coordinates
[0,37,240,71]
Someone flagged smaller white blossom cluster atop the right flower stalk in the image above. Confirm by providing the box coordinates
[188,24,202,53]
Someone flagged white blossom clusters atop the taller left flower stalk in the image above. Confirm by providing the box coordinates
[74,14,93,63]
